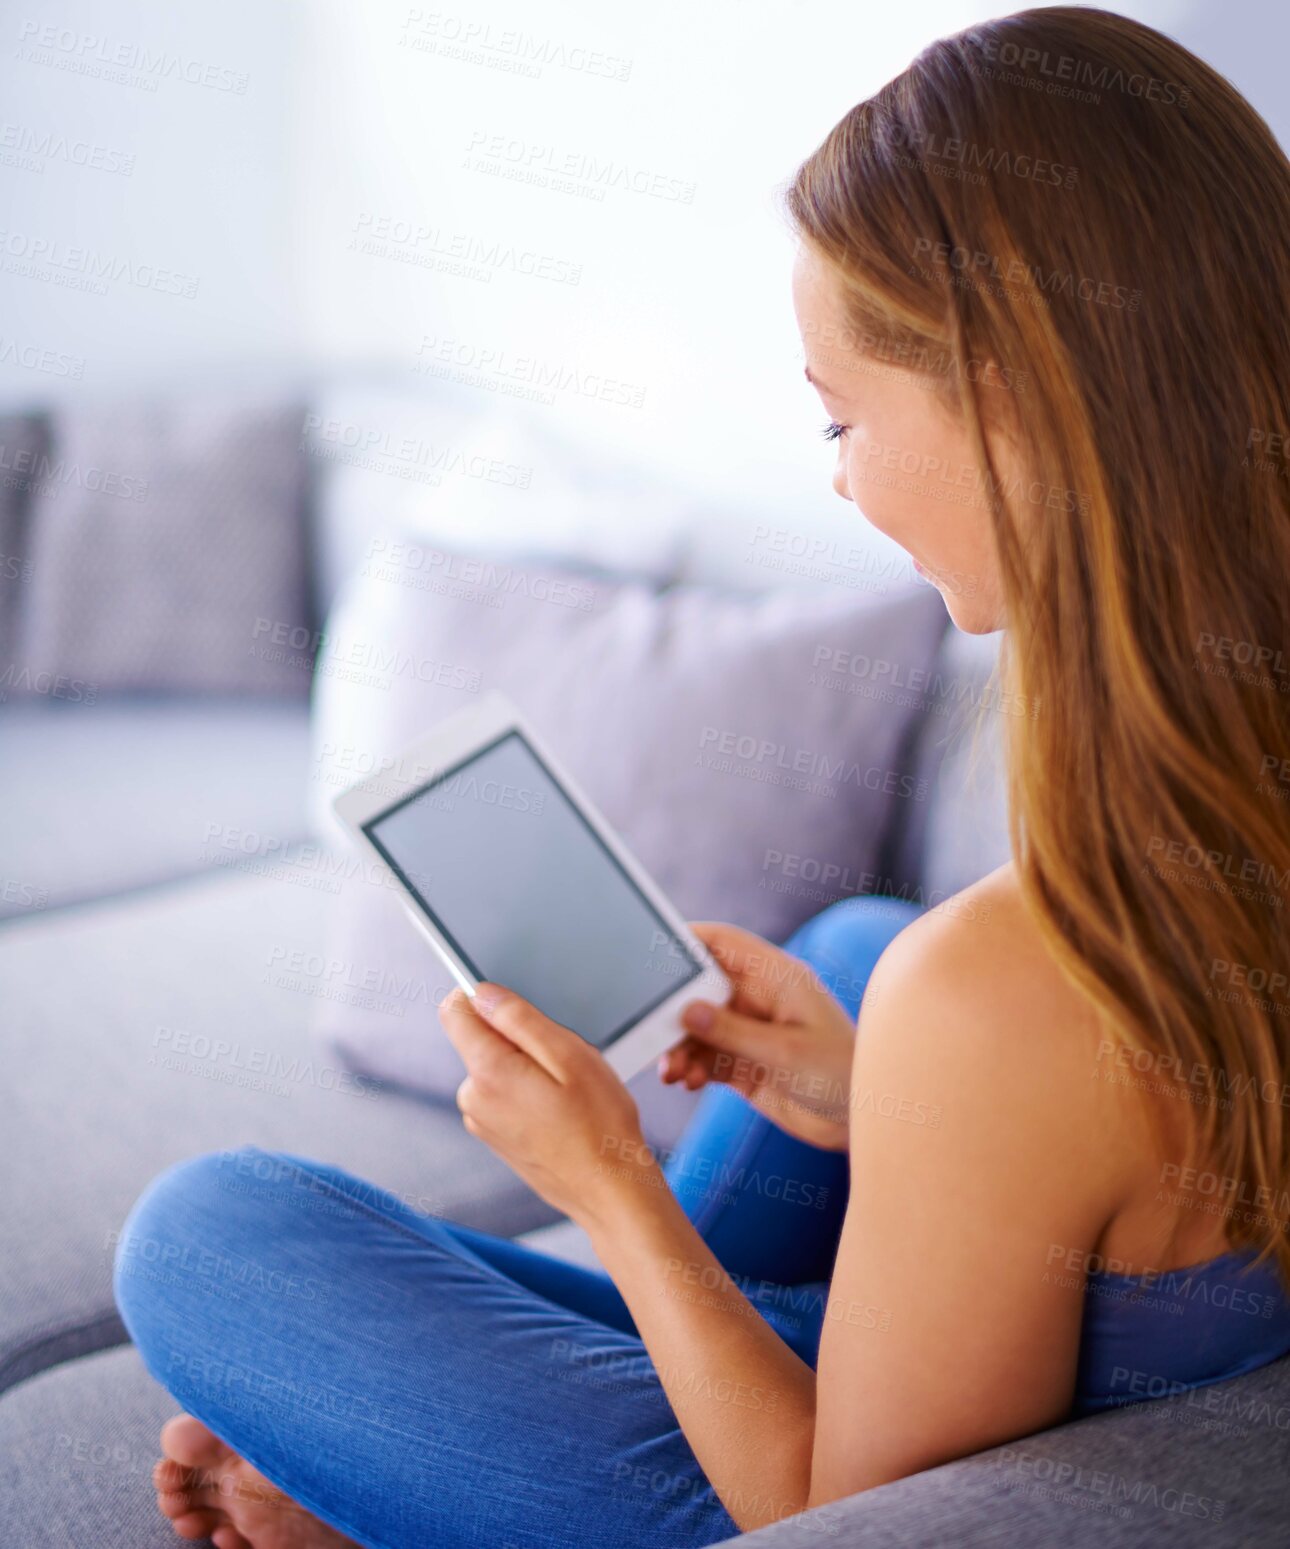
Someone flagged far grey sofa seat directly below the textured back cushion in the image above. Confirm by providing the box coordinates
[0,699,310,919]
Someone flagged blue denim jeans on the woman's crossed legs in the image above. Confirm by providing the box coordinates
[115,898,917,1549]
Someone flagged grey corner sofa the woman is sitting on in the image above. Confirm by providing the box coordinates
[0,389,1290,1549]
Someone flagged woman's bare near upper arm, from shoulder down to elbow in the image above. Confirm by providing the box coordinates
[808,908,1126,1506]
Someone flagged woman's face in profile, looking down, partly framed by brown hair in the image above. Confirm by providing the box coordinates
[793,246,1010,635]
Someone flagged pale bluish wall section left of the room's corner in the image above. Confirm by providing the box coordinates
[0,0,305,404]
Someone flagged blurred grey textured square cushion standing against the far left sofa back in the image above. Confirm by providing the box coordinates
[19,400,313,697]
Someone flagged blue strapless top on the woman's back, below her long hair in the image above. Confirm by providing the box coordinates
[1073,1252,1290,1414]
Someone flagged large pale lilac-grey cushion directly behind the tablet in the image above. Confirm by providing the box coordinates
[305,541,945,1102]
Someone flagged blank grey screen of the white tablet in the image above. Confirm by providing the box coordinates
[364,731,702,1049]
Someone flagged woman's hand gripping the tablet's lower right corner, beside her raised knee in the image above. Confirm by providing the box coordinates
[658,923,855,1151]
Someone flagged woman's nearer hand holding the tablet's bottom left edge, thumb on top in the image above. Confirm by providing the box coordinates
[438,984,666,1230]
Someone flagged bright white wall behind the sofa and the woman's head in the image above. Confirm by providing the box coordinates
[0,0,1269,585]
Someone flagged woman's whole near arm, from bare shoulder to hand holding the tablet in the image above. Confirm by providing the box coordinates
[441,892,1123,1529]
